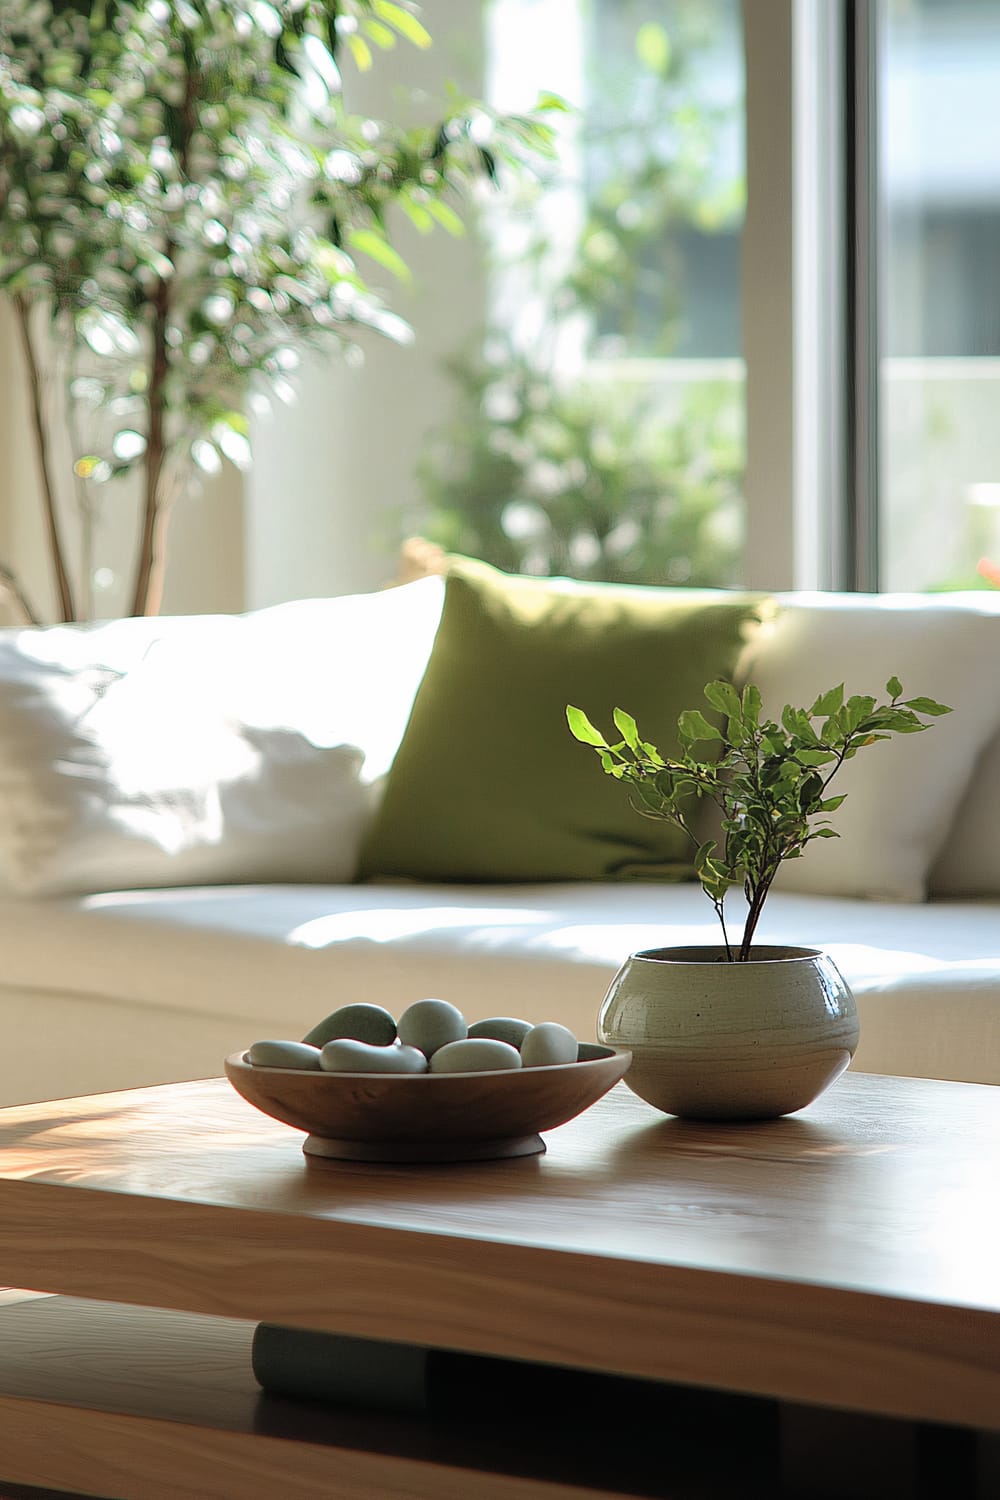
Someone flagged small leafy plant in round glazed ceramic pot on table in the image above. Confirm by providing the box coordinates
[567,677,951,1119]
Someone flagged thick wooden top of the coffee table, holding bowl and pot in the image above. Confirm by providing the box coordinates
[0,1073,1000,1427]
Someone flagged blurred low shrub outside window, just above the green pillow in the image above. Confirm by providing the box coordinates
[403,347,744,587]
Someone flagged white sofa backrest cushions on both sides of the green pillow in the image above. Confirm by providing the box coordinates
[0,578,1000,900]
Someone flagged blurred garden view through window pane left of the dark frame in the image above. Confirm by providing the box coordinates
[403,0,745,587]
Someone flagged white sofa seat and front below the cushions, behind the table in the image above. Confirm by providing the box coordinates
[0,882,1000,1103]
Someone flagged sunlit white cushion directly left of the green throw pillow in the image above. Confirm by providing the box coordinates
[0,579,444,896]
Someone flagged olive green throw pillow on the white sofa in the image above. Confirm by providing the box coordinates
[361,558,763,882]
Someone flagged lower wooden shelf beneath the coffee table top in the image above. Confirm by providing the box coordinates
[0,1295,996,1500]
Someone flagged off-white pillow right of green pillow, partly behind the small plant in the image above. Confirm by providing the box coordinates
[739,593,1000,902]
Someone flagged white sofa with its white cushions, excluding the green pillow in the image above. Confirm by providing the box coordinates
[0,578,1000,1104]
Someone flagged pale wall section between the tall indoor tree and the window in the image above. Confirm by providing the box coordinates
[246,0,486,608]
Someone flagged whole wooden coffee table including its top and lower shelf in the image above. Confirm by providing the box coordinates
[0,1074,1000,1500]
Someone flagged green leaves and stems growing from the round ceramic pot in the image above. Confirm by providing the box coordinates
[567,677,951,962]
